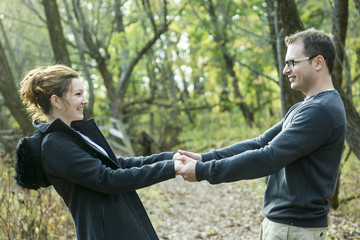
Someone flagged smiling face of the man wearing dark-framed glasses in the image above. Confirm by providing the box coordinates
[283,40,314,96]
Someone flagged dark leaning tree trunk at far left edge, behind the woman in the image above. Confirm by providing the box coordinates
[0,41,34,135]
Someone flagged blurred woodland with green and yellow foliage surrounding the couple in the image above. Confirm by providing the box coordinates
[0,0,360,239]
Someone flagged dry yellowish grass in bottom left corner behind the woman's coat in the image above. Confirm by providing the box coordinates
[0,156,75,240]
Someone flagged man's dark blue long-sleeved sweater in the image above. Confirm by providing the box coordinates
[196,90,346,227]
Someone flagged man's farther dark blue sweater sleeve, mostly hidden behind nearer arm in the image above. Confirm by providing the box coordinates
[201,121,282,162]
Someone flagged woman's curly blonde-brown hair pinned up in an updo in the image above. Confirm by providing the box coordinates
[20,64,79,120]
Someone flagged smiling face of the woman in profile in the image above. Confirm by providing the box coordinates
[58,78,89,126]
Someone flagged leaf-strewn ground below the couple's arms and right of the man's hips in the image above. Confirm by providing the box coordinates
[139,177,360,240]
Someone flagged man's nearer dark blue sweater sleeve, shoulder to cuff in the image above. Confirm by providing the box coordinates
[196,106,333,184]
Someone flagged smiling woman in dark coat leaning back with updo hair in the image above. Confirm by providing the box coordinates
[15,65,182,239]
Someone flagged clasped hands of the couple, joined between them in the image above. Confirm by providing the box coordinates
[173,150,202,182]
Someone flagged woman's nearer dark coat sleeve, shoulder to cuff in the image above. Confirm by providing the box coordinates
[42,133,175,194]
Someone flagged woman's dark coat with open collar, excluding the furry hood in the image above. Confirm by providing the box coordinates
[22,119,175,240]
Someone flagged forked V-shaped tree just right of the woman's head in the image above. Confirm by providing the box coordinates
[73,0,170,119]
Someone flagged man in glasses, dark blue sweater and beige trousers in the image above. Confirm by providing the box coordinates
[174,28,346,240]
